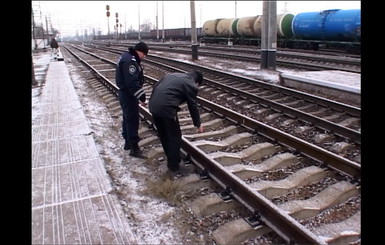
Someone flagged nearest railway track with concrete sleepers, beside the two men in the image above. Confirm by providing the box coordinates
[60,43,361,244]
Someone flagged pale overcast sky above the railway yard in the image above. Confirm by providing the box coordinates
[32,1,361,36]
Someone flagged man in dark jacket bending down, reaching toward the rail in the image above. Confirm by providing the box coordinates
[149,71,203,174]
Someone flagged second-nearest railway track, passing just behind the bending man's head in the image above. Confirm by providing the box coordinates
[81,42,361,163]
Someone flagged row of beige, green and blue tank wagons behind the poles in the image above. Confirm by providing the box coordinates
[201,9,361,53]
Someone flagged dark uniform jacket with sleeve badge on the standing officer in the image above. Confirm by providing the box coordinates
[115,48,146,102]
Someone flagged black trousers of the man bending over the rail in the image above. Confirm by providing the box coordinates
[152,115,182,171]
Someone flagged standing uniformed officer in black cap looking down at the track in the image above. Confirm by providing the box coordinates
[115,42,148,158]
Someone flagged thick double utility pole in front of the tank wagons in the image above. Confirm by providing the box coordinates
[261,1,277,70]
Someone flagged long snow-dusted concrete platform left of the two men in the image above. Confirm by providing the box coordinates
[31,57,138,244]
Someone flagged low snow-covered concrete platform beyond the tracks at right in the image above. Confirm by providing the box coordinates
[281,70,361,103]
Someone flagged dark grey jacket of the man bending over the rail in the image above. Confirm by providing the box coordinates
[149,73,201,127]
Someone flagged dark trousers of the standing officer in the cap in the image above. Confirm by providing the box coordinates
[119,90,140,145]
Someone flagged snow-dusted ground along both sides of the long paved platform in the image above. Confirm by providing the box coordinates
[31,49,183,244]
